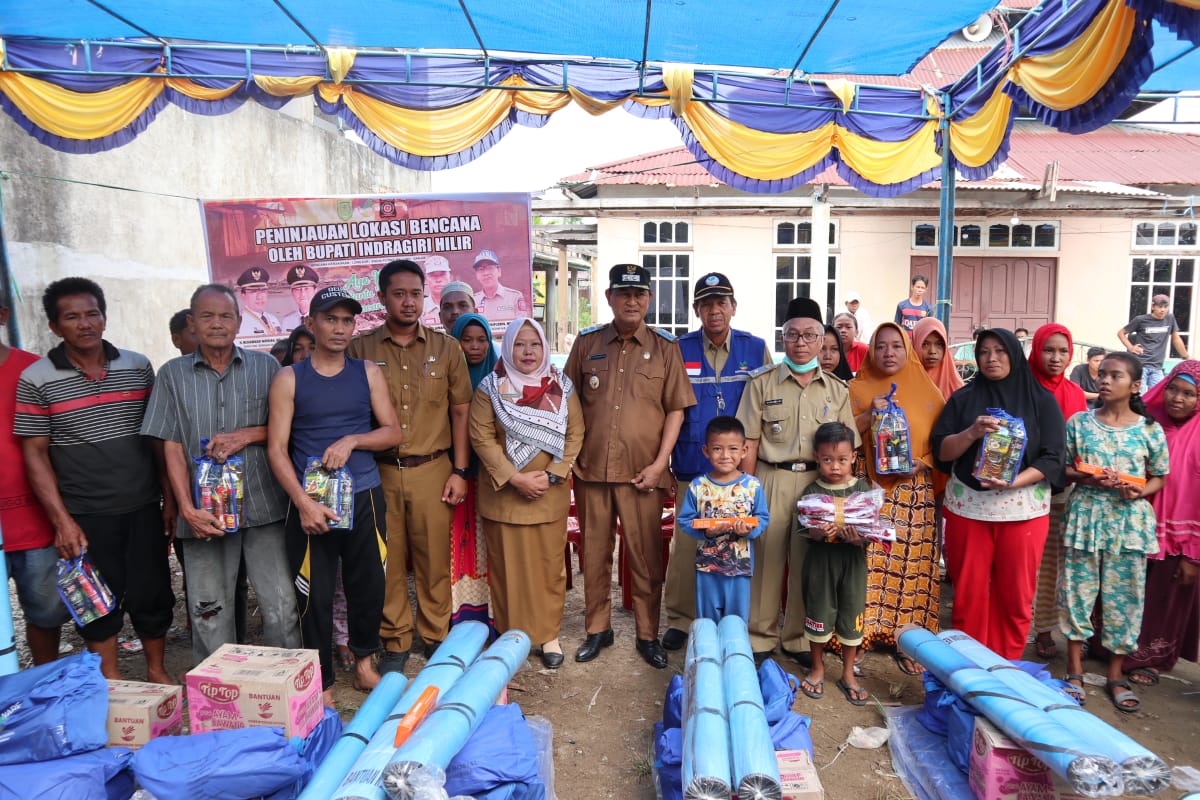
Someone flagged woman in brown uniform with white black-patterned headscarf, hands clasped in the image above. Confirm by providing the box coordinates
[470,317,583,669]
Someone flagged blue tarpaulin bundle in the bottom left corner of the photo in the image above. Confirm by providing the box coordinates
[0,748,133,800]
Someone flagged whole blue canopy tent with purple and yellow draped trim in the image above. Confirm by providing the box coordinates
[0,0,1200,315]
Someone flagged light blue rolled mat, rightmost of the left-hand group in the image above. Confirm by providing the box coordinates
[383,631,529,800]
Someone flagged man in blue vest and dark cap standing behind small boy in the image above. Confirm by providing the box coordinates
[662,272,772,650]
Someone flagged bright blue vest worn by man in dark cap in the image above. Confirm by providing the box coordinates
[671,330,767,482]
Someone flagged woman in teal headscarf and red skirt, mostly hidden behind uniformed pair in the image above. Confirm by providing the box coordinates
[450,314,498,625]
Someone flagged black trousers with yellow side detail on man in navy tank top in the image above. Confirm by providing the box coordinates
[284,487,388,688]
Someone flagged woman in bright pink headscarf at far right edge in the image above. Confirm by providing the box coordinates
[1092,361,1200,685]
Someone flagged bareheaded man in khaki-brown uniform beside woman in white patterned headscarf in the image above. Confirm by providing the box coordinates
[349,259,472,673]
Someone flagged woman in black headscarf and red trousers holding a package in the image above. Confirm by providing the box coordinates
[932,329,1067,658]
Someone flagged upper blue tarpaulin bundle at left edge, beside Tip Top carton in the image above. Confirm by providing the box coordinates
[0,652,108,764]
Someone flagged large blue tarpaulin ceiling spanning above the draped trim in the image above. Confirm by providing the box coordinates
[0,0,995,74]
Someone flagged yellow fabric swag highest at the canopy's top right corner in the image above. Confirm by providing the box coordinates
[1008,0,1140,112]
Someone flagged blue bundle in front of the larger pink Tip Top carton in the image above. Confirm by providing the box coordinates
[133,728,311,800]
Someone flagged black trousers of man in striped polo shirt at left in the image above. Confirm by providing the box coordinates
[74,503,175,642]
